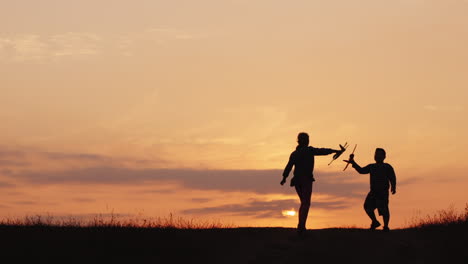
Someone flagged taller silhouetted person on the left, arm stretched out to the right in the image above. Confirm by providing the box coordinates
[281,132,344,234]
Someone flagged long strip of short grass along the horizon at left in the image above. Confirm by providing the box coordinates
[0,213,234,229]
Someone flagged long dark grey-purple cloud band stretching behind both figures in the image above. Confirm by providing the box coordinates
[8,167,368,197]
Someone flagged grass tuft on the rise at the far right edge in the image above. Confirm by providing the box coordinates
[408,203,468,228]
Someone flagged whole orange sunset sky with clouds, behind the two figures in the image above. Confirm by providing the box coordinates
[0,0,468,228]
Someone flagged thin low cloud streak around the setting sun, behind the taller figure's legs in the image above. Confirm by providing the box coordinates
[181,199,349,218]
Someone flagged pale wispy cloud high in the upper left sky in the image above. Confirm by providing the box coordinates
[0,27,197,62]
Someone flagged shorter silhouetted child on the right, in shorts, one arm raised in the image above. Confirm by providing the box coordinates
[345,148,396,231]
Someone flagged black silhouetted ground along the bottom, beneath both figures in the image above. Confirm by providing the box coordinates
[0,225,468,264]
